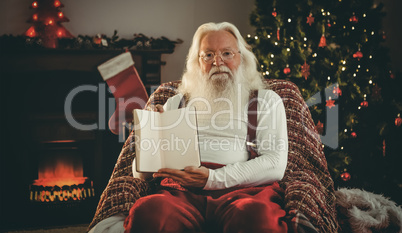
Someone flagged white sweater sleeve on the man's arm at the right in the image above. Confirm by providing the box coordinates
[204,90,288,190]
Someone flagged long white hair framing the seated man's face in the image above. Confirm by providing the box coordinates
[179,22,264,93]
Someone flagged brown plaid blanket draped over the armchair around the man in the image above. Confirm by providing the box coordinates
[88,79,338,233]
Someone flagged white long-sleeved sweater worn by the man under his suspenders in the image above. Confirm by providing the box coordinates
[163,90,288,190]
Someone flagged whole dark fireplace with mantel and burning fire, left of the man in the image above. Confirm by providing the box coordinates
[0,49,173,231]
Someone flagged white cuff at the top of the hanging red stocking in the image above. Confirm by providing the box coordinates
[98,52,134,81]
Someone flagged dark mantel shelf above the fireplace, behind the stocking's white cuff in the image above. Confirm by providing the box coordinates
[0,49,173,89]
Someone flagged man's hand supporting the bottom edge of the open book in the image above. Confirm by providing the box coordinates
[154,166,209,188]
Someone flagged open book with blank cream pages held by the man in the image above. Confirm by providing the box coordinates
[133,107,201,172]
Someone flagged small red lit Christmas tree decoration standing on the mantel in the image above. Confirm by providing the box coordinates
[25,0,73,48]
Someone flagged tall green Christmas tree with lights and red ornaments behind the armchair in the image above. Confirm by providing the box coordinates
[246,0,402,202]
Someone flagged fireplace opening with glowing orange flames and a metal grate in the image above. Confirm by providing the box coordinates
[30,140,95,203]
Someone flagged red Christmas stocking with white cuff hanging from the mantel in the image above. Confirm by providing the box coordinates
[98,52,148,134]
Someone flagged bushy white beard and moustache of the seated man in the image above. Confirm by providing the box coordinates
[180,66,250,120]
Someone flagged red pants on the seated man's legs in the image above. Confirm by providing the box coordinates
[124,183,287,233]
